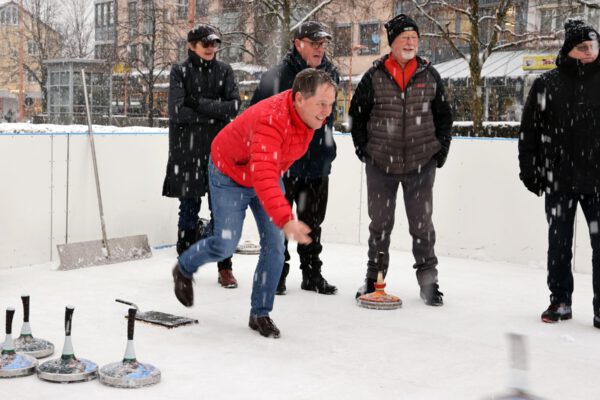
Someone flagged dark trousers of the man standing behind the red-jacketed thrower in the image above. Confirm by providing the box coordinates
[283,176,329,269]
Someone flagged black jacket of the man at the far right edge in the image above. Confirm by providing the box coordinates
[519,53,600,195]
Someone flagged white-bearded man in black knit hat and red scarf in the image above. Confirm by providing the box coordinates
[349,14,452,306]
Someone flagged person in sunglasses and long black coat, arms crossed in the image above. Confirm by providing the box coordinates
[163,24,240,288]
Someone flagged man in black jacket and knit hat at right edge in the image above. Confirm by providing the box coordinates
[519,19,600,328]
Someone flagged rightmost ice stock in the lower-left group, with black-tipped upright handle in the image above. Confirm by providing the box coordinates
[98,308,160,389]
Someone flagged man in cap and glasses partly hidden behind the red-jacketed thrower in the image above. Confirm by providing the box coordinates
[251,21,340,295]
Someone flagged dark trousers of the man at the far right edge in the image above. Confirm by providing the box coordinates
[545,192,600,316]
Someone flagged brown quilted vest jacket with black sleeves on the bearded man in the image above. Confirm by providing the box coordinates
[349,55,453,174]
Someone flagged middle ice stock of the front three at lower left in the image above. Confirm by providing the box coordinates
[38,306,98,383]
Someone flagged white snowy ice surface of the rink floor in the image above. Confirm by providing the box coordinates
[0,243,600,400]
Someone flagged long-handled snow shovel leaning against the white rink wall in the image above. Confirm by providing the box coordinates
[56,69,152,270]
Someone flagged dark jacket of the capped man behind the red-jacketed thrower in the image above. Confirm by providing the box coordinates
[250,47,340,179]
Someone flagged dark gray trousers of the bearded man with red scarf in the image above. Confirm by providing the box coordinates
[366,160,438,285]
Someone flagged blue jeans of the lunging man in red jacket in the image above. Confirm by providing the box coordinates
[179,160,284,317]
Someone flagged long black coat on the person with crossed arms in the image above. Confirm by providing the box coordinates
[163,51,240,198]
